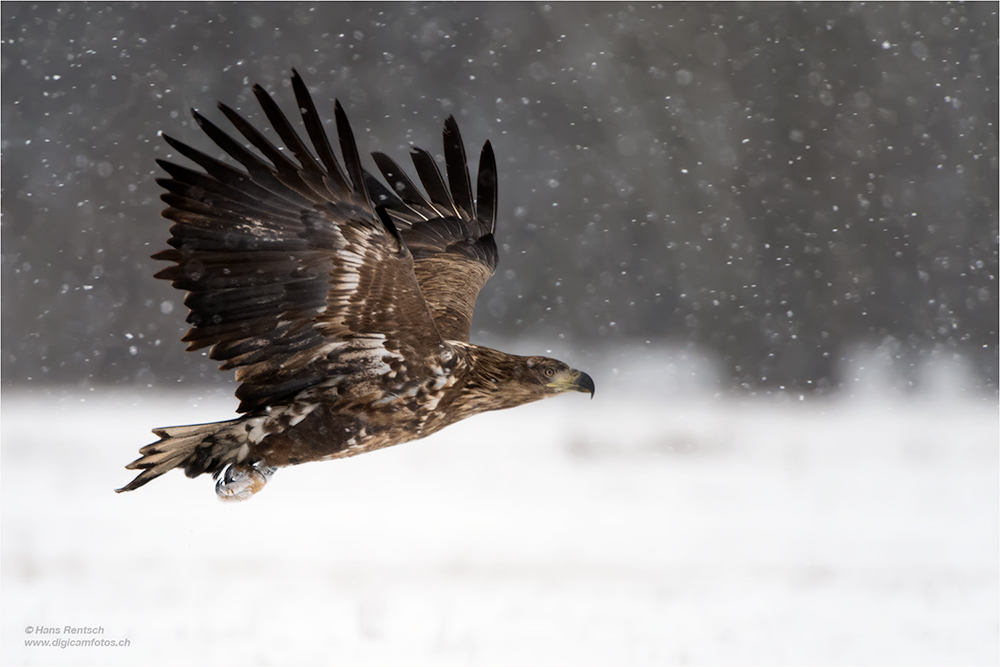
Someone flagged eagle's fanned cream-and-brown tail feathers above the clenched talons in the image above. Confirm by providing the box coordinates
[115,418,247,493]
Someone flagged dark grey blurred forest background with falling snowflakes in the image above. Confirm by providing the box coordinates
[0,2,998,391]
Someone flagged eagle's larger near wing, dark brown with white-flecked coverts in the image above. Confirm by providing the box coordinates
[153,70,444,412]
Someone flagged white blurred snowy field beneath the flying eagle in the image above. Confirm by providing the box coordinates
[0,378,1000,665]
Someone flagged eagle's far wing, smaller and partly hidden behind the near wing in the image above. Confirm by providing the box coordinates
[369,116,497,342]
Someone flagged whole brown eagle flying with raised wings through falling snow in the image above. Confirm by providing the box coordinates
[117,69,594,501]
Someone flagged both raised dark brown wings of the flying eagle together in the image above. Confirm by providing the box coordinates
[154,73,496,412]
